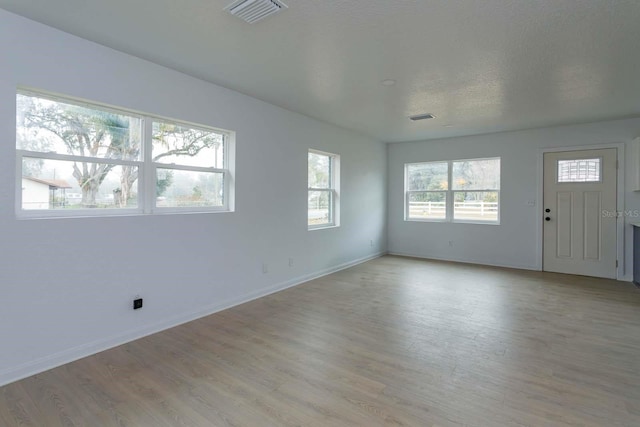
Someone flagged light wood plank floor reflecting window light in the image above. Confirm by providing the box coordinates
[0,256,640,427]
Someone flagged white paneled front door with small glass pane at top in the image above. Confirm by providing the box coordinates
[542,148,617,279]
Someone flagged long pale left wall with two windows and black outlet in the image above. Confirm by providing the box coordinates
[0,10,387,384]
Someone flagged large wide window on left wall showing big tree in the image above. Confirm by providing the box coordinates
[16,92,231,217]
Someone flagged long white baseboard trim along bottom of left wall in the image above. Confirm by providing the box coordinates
[0,252,386,386]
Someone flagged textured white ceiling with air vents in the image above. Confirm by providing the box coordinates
[0,0,640,142]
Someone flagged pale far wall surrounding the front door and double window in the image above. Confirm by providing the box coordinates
[387,119,640,280]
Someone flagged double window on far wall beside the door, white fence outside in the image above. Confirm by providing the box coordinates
[405,158,500,224]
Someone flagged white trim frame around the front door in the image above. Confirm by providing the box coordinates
[536,142,625,280]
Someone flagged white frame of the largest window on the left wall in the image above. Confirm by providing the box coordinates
[15,89,235,219]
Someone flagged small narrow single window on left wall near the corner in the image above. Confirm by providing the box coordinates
[307,150,340,229]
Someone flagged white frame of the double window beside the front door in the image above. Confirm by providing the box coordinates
[404,157,502,225]
